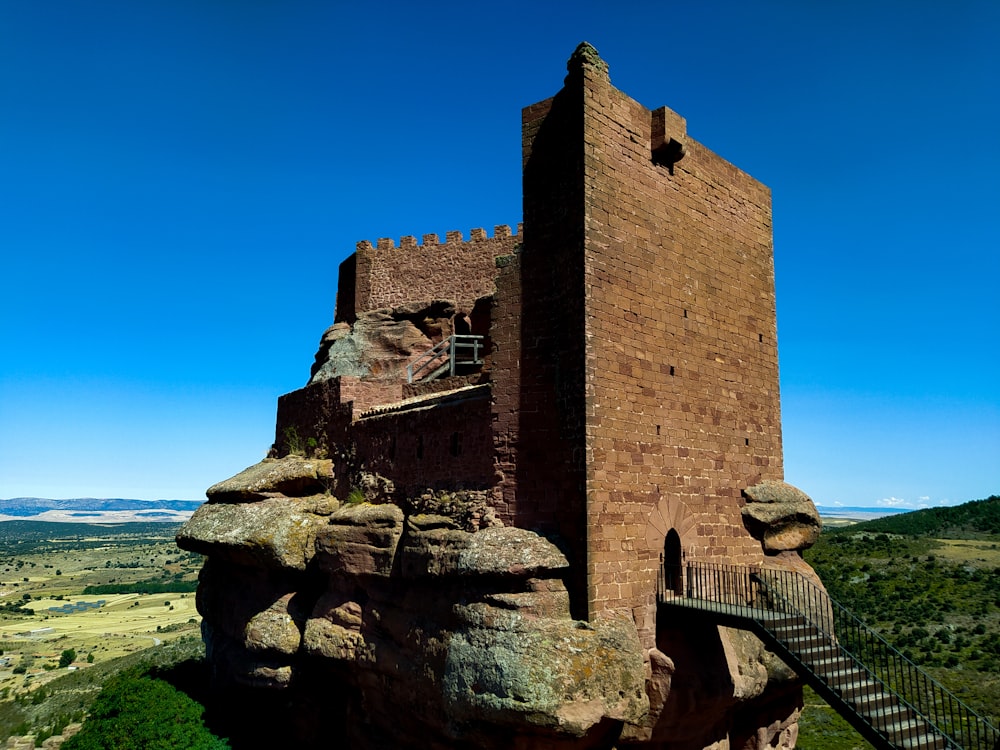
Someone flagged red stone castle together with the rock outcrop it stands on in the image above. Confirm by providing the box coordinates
[179,44,819,748]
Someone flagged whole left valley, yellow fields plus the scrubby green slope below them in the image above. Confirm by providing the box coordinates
[0,521,207,747]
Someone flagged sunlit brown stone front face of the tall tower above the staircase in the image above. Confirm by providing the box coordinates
[581,55,782,619]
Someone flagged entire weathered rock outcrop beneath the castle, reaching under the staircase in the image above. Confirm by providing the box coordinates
[178,456,818,750]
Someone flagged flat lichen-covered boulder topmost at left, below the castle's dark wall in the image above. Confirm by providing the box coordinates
[205,456,333,503]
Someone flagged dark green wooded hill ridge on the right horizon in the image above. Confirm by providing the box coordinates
[820,495,1000,539]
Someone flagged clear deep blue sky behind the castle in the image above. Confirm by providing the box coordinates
[0,0,1000,507]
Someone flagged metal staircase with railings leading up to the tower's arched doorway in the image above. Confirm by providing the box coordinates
[657,562,1000,750]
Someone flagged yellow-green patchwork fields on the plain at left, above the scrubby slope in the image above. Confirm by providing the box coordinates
[0,521,201,700]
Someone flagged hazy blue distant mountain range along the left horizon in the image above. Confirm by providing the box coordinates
[0,497,203,523]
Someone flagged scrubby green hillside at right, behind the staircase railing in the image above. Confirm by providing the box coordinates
[800,496,1000,750]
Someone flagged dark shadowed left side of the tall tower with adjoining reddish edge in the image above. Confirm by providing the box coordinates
[491,88,588,618]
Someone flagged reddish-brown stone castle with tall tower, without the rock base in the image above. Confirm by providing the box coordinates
[275,45,782,646]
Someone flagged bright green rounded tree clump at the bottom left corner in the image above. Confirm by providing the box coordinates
[63,667,229,750]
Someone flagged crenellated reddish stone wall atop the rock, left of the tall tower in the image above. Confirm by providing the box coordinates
[336,224,524,323]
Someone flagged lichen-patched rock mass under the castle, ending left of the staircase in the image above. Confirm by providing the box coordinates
[178,457,649,748]
